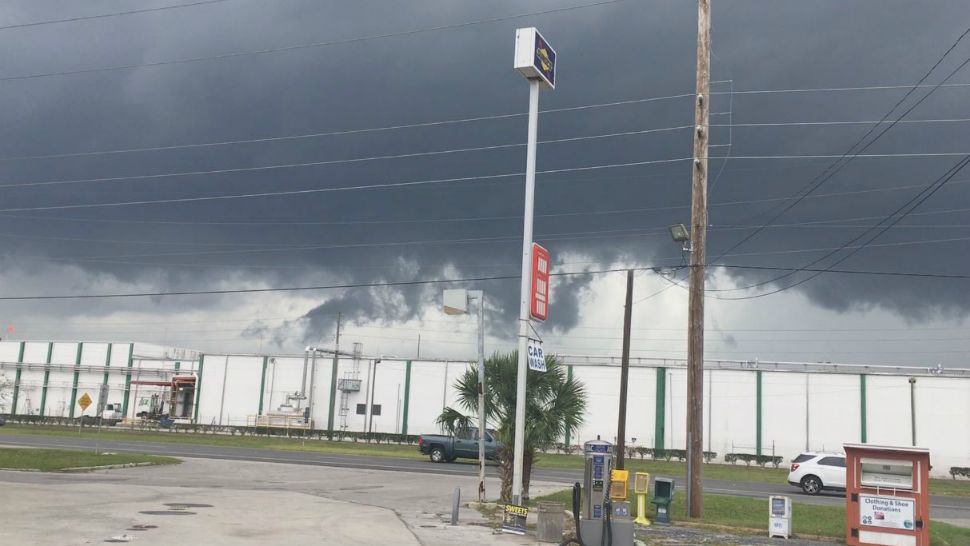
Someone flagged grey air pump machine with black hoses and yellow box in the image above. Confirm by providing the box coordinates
[579,440,633,546]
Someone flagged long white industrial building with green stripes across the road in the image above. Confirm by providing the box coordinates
[0,340,970,475]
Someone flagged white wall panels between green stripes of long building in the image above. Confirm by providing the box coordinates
[0,341,970,475]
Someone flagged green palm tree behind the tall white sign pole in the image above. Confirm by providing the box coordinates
[438,351,586,502]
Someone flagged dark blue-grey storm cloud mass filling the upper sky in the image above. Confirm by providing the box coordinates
[0,0,970,340]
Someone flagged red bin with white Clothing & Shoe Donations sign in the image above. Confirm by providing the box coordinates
[844,444,930,546]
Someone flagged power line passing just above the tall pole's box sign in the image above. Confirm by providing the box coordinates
[0,0,626,81]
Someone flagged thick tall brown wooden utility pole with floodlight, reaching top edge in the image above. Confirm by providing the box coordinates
[687,0,711,518]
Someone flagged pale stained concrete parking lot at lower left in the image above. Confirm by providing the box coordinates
[0,459,562,546]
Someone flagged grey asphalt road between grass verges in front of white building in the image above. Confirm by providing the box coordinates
[0,434,970,526]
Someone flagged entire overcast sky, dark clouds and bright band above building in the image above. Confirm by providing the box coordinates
[0,0,970,366]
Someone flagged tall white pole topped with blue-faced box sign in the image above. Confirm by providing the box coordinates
[512,28,556,504]
